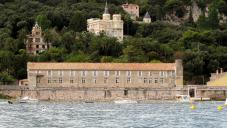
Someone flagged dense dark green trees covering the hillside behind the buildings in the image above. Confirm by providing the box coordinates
[0,0,227,84]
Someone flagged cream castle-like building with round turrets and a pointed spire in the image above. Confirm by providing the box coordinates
[87,3,124,41]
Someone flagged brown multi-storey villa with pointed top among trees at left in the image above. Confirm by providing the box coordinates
[26,22,51,55]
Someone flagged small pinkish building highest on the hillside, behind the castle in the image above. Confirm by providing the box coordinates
[121,3,140,20]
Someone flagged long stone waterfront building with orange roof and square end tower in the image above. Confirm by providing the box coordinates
[27,60,183,88]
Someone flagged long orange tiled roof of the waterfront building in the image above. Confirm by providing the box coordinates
[27,62,176,71]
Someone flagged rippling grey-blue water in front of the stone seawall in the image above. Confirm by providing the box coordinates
[0,102,227,128]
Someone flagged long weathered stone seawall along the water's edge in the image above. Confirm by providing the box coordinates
[0,87,227,101]
